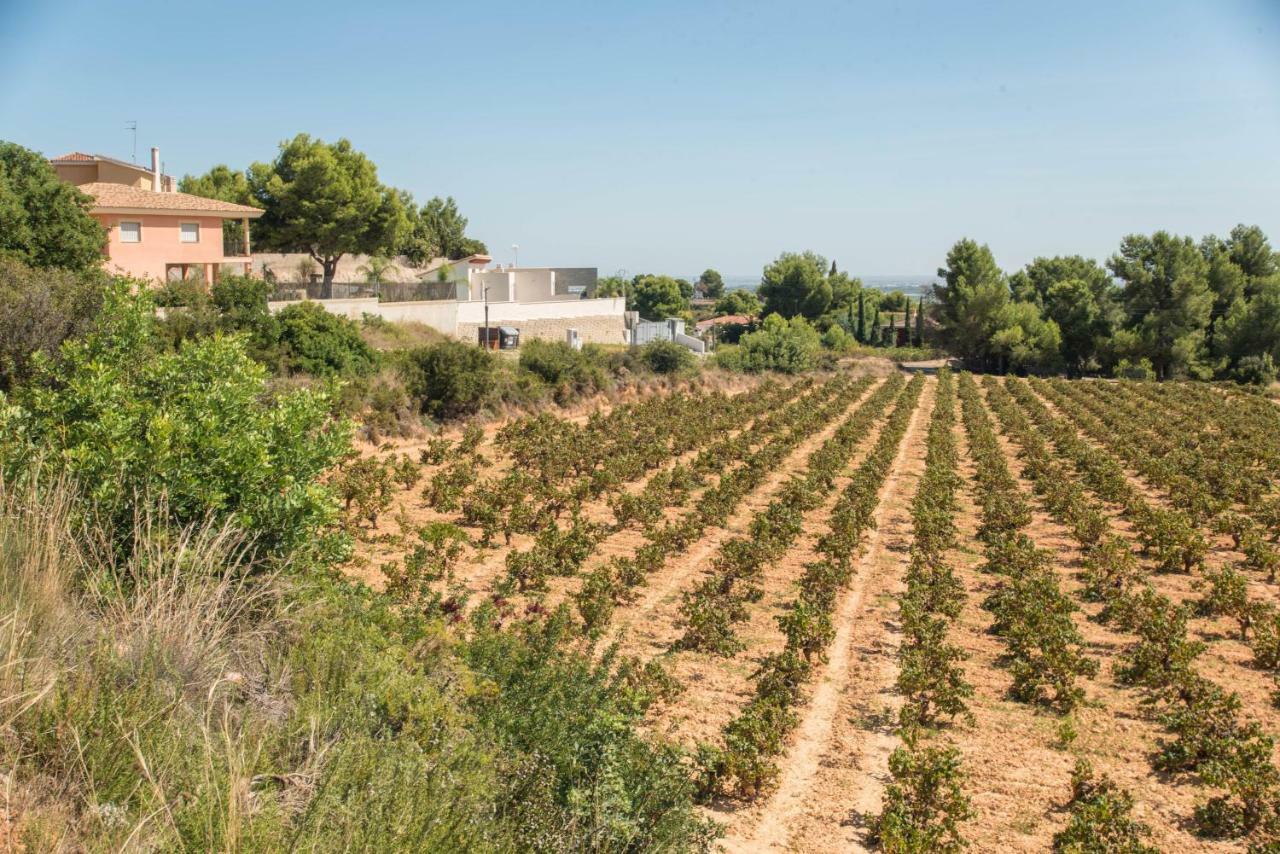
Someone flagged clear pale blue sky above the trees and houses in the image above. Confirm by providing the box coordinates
[0,0,1280,275]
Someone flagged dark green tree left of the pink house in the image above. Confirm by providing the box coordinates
[0,141,106,270]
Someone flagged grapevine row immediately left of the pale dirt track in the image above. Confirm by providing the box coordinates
[699,375,924,798]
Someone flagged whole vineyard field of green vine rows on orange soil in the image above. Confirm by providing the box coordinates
[345,369,1280,851]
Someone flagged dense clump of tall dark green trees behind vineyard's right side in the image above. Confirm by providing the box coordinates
[936,224,1280,382]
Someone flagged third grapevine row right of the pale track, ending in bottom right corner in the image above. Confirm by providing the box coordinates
[989,383,1280,844]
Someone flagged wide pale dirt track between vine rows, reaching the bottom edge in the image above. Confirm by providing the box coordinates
[718,379,937,851]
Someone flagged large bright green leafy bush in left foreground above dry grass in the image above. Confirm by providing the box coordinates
[8,280,348,553]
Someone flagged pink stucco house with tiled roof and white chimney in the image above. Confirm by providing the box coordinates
[50,149,262,283]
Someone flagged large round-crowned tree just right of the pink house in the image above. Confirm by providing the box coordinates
[248,133,407,283]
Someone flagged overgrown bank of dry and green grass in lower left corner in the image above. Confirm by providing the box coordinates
[0,483,713,851]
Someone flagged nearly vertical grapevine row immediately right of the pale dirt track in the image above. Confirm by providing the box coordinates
[872,370,974,854]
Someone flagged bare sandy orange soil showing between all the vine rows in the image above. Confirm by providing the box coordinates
[335,378,1280,851]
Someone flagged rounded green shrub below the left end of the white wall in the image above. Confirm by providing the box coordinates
[276,301,378,376]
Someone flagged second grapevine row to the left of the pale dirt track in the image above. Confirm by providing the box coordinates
[678,375,904,656]
